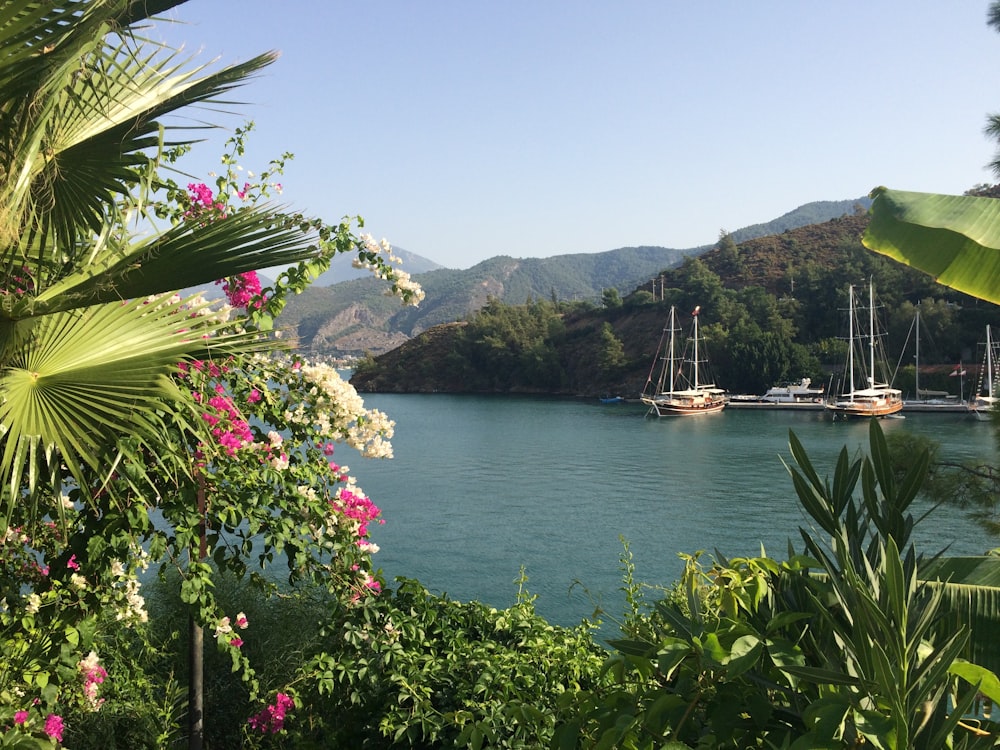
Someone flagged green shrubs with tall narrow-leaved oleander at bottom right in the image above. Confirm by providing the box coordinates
[556,420,1000,750]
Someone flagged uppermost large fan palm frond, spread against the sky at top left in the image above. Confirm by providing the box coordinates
[0,0,275,271]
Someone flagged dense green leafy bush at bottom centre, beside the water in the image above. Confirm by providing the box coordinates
[290,579,605,748]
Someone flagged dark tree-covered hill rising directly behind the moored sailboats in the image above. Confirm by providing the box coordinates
[352,214,1000,397]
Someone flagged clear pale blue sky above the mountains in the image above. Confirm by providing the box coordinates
[155,0,1000,268]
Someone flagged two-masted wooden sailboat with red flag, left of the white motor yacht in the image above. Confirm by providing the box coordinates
[642,305,726,417]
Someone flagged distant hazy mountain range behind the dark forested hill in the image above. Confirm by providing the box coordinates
[280,198,871,357]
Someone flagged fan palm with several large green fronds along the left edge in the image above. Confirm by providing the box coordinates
[0,0,317,517]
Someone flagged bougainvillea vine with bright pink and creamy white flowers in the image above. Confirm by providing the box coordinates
[0,126,423,747]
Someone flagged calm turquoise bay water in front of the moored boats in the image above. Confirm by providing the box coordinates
[340,394,1000,625]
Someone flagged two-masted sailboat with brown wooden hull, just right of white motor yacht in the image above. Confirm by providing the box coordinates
[826,283,903,419]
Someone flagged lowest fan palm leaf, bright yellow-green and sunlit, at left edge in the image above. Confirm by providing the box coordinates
[0,299,270,512]
